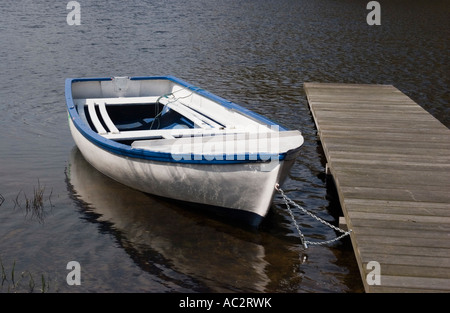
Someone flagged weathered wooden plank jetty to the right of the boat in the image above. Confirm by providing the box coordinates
[304,83,450,292]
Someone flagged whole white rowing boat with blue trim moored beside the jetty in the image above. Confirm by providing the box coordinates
[65,76,303,226]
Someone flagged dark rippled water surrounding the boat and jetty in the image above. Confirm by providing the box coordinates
[0,0,450,293]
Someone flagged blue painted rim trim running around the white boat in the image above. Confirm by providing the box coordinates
[65,76,287,164]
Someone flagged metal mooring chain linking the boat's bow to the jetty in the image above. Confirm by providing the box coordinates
[275,184,352,249]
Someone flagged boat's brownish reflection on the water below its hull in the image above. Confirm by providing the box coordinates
[67,147,270,292]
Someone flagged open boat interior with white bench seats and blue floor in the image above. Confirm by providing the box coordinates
[72,77,271,141]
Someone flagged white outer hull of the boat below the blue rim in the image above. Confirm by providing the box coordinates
[69,118,298,226]
